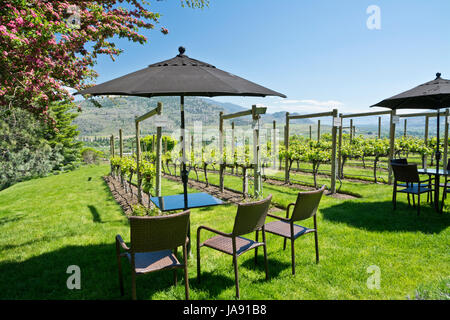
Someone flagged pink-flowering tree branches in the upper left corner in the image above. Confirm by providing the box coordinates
[0,0,208,122]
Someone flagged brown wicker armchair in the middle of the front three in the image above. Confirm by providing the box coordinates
[197,195,272,298]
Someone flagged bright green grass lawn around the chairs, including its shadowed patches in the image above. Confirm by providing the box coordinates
[0,165,450,300]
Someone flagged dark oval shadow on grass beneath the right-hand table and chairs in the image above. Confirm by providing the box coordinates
[320,201,450,234]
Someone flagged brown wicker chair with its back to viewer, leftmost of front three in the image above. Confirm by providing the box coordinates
[116,211,190,300]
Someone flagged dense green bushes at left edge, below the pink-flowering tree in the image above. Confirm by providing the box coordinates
[0,103,81,189]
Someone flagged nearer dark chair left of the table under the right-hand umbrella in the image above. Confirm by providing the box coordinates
[392,164,434,215]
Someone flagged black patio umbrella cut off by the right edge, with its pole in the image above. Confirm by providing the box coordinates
[371,73,450,209]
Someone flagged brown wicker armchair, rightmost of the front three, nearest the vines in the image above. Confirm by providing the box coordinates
[265,186,326,274]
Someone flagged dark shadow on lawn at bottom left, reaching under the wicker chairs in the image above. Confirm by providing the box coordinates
[0,243,193,300]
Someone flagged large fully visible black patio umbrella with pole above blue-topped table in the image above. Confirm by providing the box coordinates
[76,47,286,207]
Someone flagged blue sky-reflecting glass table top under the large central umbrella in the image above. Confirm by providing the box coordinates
[150,192,223,211]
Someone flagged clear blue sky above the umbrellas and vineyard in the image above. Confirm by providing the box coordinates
[88,0,450,113]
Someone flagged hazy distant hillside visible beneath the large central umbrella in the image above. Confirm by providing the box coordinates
[74,97,310,137]
